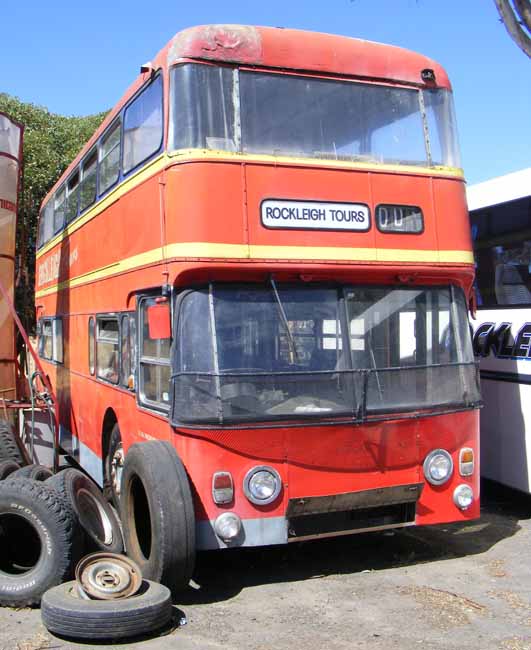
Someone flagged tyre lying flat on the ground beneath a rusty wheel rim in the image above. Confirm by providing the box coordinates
[41,580,173,641]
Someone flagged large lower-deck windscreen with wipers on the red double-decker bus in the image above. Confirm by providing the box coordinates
[171,283,479,425]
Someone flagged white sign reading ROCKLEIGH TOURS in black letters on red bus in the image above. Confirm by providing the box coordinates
[260,199,370,230]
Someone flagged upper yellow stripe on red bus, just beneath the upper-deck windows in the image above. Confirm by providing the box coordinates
[37,149,463,259]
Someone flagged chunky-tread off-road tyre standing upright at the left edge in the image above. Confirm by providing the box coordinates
[0,478,76,607]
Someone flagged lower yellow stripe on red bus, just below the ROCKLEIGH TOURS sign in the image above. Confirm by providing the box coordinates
[35,242,474,298]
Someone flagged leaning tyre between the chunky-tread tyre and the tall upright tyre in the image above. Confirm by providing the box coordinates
[46,467,124,553]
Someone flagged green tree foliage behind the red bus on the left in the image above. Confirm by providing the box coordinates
[0,93,106,330]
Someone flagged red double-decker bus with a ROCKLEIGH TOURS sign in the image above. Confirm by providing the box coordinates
[36,25,480,584]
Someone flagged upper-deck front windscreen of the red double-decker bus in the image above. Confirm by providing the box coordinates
[170,64,460,167]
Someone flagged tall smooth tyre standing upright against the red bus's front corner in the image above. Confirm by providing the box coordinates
[120,441,195,592]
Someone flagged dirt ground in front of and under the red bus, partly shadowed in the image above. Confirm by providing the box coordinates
[0,484,531,650]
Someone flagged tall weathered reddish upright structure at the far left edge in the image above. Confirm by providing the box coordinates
[0,113,23,399]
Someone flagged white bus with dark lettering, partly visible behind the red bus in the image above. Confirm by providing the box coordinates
[467,167,531,493]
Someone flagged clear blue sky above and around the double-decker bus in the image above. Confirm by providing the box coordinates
[0,0,531,183]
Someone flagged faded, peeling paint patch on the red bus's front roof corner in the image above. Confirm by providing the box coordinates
[168,25,262,65]
